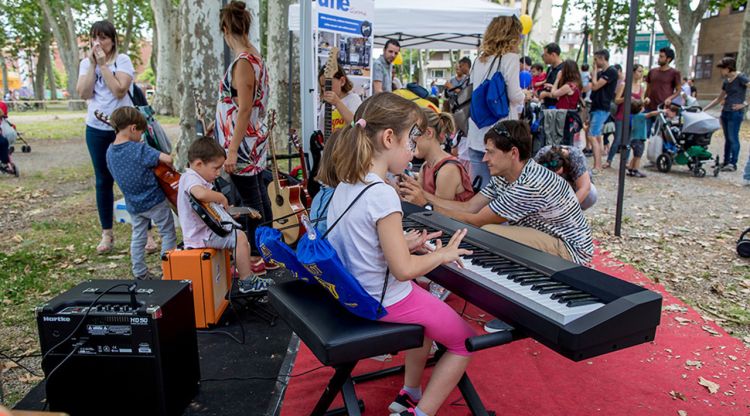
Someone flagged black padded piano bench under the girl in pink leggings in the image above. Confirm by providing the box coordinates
[269,280,424,416]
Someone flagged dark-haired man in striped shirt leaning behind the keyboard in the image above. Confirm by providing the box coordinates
[400,120,594,264]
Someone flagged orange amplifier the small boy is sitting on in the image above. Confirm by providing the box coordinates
[161,248,232,328]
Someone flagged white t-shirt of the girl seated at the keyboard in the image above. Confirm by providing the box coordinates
[327,172,411,307]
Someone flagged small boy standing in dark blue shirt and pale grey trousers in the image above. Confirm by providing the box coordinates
[107,107,177,280]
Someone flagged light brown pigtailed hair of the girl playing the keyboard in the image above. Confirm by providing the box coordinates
[318,92,427,186]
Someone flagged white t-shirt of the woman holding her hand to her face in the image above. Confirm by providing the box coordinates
[78,53,135,130]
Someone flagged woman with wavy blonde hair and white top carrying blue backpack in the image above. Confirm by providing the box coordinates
[467,16,526,191]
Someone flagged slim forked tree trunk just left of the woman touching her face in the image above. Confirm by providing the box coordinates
[40,0,85,110]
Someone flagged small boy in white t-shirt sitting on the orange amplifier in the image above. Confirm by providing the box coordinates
[177,137,273,293]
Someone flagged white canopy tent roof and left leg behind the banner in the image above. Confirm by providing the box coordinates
[289,0,519,151]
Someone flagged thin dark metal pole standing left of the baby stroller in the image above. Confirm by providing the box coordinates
[615,0,638,237]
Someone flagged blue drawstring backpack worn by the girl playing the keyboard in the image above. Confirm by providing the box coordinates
[297,182,388,320]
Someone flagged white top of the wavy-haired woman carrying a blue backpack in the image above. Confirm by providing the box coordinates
[467,53,526,152]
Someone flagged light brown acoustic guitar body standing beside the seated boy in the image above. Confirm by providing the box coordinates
[268,182,307,245]
